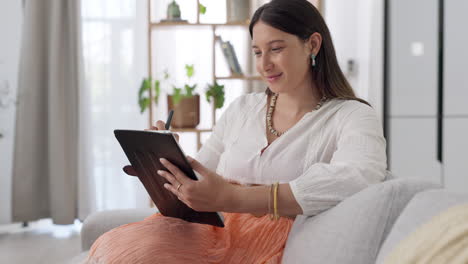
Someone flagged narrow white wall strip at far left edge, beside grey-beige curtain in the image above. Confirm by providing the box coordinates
[0,0,22,224]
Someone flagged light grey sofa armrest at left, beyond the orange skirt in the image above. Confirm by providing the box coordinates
[81,208,157,251]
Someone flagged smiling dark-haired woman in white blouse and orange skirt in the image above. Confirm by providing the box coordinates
[89,0,386,263]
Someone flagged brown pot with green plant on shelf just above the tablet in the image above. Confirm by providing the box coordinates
[167,65,200,128]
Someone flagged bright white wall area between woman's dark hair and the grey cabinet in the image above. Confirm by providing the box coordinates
[324,0,383,120]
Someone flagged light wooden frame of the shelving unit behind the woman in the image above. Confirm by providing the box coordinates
[148,0,261,149]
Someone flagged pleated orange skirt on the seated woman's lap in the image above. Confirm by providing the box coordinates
[86,213,294,264]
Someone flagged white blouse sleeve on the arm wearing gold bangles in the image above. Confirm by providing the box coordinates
[290,105,387,216]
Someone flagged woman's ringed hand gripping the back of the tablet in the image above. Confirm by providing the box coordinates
[158,157,237,212]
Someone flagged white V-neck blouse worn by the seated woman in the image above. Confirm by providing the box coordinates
[196,93,387,215]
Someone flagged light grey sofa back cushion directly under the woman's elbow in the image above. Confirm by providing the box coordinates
[283,179,438,264]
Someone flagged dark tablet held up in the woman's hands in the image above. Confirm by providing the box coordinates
[114,130,224,227]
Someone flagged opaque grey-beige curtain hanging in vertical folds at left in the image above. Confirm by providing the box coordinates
[12,0,79,224]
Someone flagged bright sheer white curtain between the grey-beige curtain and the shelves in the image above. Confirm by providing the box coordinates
[79,0,149,219]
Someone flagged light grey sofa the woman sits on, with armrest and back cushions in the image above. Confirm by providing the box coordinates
[70,178,468,264]
